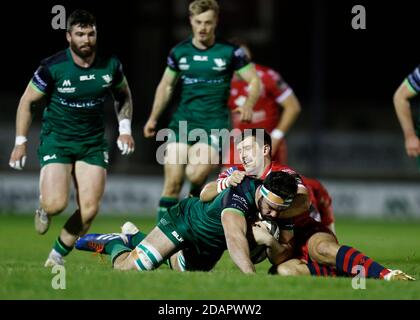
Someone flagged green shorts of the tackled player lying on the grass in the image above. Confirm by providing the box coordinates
[157,199,224,271]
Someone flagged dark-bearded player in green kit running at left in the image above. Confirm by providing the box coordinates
[9,10,134,267]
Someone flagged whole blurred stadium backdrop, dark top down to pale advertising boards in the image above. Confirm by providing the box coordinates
[0,0,420,217]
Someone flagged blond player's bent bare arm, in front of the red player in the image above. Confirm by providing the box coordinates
[232,63,261,122]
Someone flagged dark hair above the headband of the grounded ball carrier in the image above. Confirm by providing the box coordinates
[263,171,298,204]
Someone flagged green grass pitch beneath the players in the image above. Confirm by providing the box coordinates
[0,215,420,300]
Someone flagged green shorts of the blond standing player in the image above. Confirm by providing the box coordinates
[168,117,230,152]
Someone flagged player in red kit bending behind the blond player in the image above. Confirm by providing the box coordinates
[229,42,301,165]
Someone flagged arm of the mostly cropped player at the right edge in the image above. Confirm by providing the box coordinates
[394,67,420,157]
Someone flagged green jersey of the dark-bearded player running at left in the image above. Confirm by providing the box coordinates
[30,49,124,140]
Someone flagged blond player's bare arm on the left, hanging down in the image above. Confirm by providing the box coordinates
[144,67,178,138]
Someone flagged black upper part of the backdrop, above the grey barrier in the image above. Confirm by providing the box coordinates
[0,0,420,178]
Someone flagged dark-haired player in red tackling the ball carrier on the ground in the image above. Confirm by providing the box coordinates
[200,127,414,280]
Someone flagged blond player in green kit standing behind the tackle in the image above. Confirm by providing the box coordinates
[144,0,260,219]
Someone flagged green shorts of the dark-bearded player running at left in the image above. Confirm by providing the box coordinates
[38,134,109,169]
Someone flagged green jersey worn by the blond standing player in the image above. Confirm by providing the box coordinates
[167,37,250,127]
